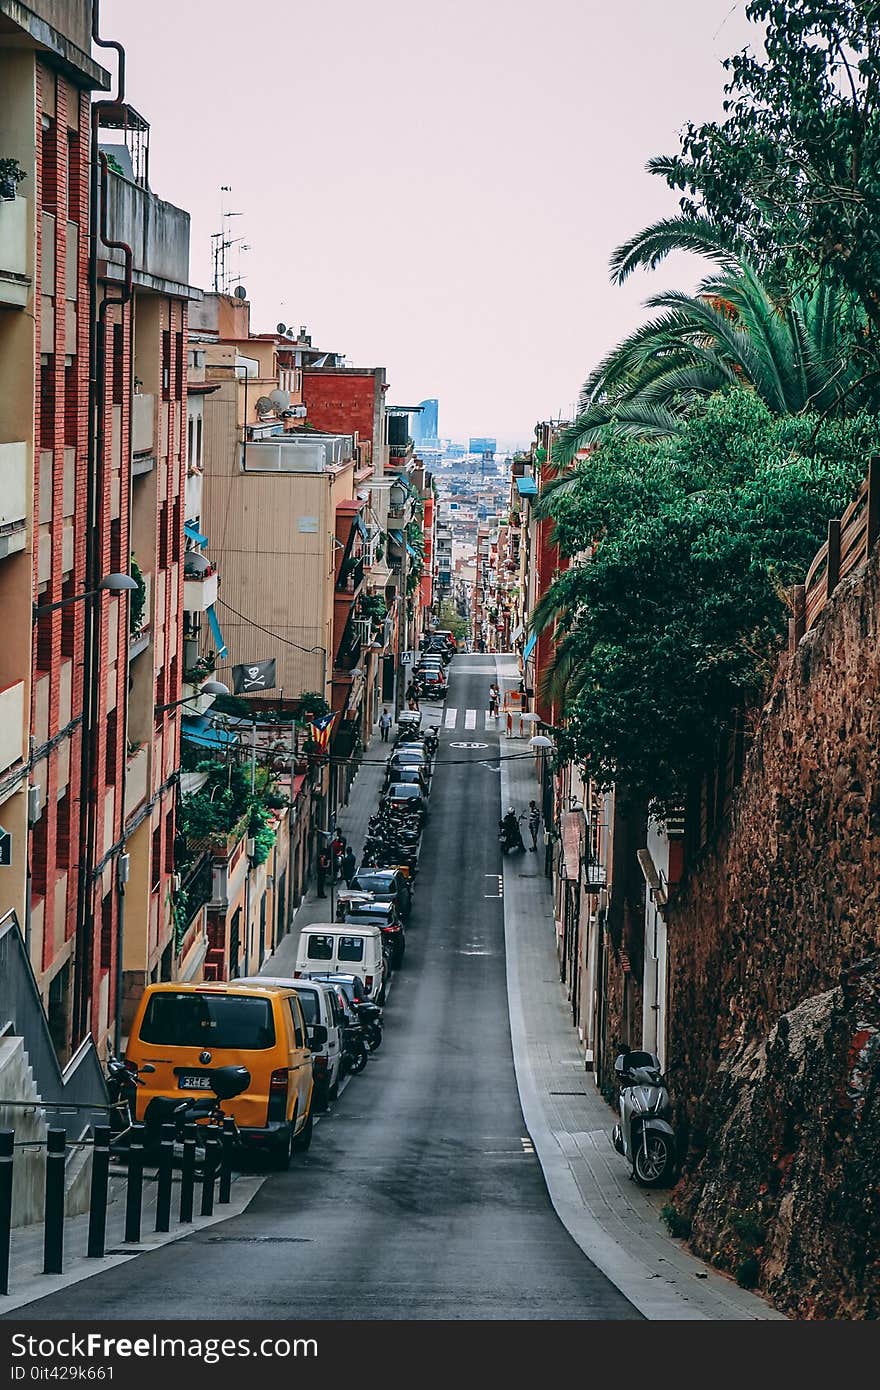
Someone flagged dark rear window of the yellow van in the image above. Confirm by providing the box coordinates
[140,992,275,1051]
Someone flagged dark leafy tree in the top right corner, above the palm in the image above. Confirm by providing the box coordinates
[648,0,880,328]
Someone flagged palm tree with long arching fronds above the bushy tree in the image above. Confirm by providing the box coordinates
[553,217,866,466]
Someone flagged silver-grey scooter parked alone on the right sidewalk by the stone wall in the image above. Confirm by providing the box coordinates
[612,1052,677,1187]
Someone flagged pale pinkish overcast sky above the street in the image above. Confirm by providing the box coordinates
[101,0,758,446]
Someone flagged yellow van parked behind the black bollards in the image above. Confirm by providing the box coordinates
[125,980,311,1168]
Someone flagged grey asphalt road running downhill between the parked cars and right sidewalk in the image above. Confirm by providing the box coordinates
[21,656,639,1321]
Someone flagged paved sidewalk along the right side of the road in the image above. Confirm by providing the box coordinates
[500,717,784,1321]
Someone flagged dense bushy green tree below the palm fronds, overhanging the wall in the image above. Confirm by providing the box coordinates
[534,389,880,806]
